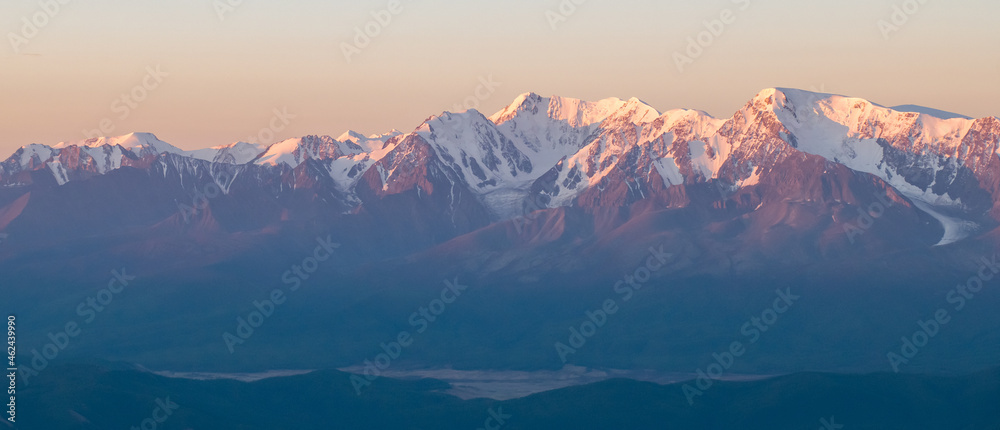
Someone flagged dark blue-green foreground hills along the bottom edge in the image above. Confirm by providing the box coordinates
[13,365,1000,430]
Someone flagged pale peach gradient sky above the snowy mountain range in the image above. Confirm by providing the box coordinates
[0,0,1000,155]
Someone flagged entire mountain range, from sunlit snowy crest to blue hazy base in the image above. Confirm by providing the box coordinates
[0,89,1000,374]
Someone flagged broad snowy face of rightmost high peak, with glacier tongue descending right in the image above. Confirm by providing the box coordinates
[755,89,997,244]
